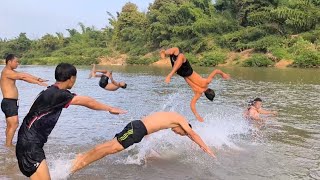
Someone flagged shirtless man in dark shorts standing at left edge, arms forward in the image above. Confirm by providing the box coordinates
[0,54,48,147]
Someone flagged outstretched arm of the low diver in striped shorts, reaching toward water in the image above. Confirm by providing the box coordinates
[180,119,215,157]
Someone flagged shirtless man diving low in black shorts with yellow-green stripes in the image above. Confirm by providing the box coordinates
[71,112,215,173]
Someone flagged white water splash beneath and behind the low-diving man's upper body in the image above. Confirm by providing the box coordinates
[117,93,251,165]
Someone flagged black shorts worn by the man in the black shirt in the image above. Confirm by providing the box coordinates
[16,140,46,177]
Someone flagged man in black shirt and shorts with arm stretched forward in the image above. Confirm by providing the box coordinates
[16,63,125,180]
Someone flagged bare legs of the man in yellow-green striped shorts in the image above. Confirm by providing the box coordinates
[71,138,124,173]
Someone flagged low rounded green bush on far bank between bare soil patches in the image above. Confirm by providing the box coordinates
[242,54,274,67]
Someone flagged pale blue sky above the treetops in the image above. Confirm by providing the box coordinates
[0,0,154,39]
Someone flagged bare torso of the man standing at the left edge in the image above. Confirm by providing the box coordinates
[0,68,18,99]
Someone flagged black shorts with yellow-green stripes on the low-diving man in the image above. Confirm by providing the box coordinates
[115,120,148,149]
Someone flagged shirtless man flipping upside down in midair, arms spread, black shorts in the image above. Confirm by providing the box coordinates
[160,47,230,122]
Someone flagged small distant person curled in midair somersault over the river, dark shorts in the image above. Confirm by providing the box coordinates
[89,64,127,91]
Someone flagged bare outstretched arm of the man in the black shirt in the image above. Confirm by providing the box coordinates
[70,96,126,114]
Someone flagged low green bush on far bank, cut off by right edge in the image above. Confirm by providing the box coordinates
[292,51,320,67]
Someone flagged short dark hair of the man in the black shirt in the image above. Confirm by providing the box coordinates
[54,63,77,82]
